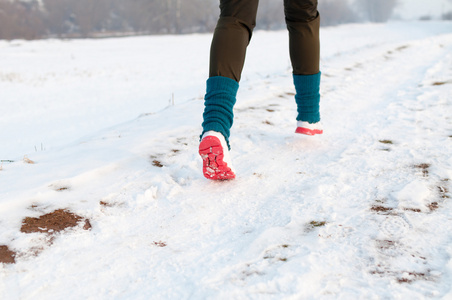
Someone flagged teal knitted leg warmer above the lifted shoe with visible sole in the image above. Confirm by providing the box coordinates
[201,76,239,148]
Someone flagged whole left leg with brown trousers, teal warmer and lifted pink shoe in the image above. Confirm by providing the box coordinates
[199,0,259,180]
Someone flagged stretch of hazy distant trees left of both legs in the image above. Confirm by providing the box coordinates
[0,0,218,39]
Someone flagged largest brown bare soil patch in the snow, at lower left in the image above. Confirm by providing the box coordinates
[20,209,91,233]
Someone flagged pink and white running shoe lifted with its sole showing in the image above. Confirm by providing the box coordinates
[199,131,235,180]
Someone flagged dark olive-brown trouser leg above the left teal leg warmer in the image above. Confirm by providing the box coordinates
[209,0,259,82]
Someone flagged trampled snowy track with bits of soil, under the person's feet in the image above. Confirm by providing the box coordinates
[0,23,452,299]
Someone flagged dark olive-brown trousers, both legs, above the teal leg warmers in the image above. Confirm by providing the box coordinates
[209,0,320,82]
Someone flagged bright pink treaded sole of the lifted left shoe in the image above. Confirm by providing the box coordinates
[199,136,235,180]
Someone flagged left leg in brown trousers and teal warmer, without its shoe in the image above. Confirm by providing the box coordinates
[202,0,259,147]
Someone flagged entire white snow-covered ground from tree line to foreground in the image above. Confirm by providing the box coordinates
[0,22,452,299]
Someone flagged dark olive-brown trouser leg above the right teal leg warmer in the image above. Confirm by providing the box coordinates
[284,0,320,75]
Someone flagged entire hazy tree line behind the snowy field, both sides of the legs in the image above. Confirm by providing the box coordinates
[0,0,414,40]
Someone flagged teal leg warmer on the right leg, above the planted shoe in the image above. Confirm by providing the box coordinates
[293,72,320,124]
